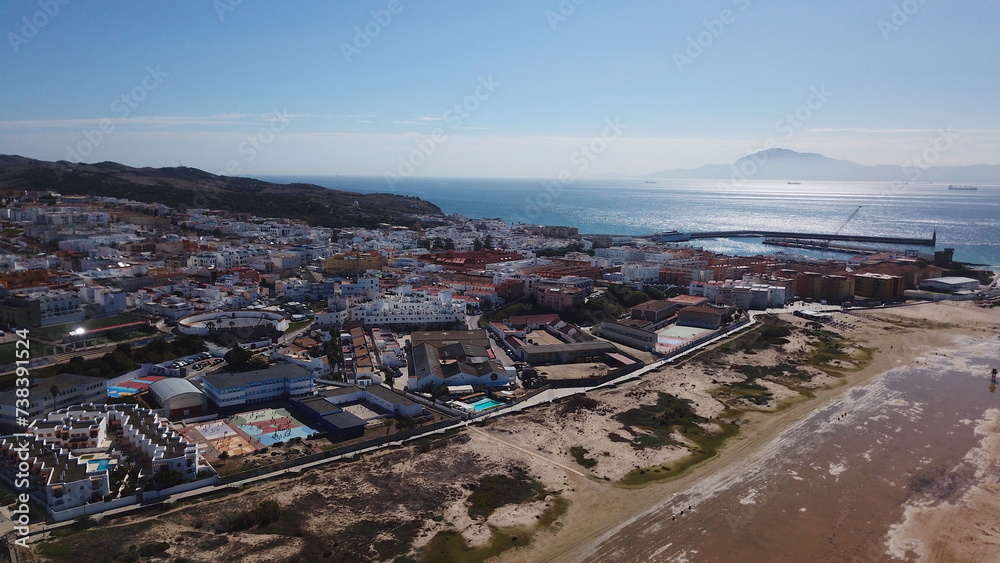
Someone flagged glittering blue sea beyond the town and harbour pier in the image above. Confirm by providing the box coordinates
[261,176,1000,266]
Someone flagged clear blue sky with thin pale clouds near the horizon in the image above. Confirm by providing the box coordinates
[0,0,1000,179]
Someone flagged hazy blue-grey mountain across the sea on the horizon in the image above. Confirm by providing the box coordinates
[645,148,1000,184]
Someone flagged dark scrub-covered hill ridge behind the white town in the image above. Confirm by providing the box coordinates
[0,155,443,227]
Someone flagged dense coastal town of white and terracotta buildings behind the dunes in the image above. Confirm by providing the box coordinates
[0,190,1000,560]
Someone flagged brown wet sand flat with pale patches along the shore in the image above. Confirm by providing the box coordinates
[574,337,1000,562]
